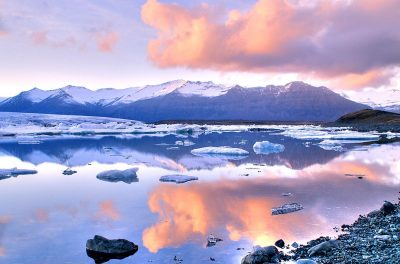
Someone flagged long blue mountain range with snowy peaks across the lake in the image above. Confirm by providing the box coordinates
[0,80,367,122]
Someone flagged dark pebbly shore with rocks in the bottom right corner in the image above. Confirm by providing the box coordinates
[242,201,400,264]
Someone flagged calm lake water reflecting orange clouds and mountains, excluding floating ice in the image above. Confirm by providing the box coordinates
[0,131,400,264]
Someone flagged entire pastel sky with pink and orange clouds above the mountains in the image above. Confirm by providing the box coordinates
[0,0,400,101]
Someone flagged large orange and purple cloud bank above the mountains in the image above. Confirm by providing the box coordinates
[141,0,400,88]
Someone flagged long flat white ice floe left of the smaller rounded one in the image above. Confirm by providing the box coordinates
[191,146,249,159]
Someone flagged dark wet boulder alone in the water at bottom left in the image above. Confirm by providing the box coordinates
[86,235,138,263]
